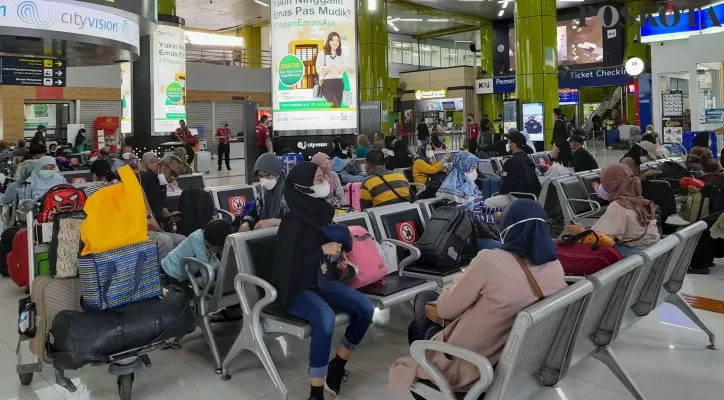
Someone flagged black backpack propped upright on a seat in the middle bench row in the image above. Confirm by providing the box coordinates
[417,207,473,267]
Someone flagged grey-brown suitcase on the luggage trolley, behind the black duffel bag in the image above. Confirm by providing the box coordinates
[30,276,83,363]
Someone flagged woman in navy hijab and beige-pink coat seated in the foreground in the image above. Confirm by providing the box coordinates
[389,199,567,399]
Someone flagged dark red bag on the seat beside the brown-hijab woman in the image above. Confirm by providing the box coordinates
[556,229,623,276]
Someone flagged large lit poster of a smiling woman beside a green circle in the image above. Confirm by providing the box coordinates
[271,0,358,131]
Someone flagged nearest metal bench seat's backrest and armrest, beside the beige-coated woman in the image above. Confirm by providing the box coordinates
[410,280,593,400]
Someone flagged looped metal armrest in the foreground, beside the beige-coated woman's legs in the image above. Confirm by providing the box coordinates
[410,340,494,400]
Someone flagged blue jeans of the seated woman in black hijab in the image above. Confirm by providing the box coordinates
[289,281,374,378]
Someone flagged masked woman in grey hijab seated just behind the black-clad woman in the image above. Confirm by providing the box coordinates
[239,153,289,232]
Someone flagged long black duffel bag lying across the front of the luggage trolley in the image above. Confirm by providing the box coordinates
[47,286,195,370]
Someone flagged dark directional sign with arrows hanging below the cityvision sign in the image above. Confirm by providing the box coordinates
[0,56,67,87]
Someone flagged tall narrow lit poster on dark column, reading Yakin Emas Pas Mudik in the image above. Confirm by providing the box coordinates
[151,25,187,136]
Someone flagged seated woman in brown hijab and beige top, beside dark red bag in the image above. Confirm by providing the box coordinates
[591,164,661,257]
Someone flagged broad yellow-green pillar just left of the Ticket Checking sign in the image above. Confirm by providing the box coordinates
[515,0,558,148]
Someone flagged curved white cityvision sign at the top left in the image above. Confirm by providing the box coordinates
[0,0,140,53]
